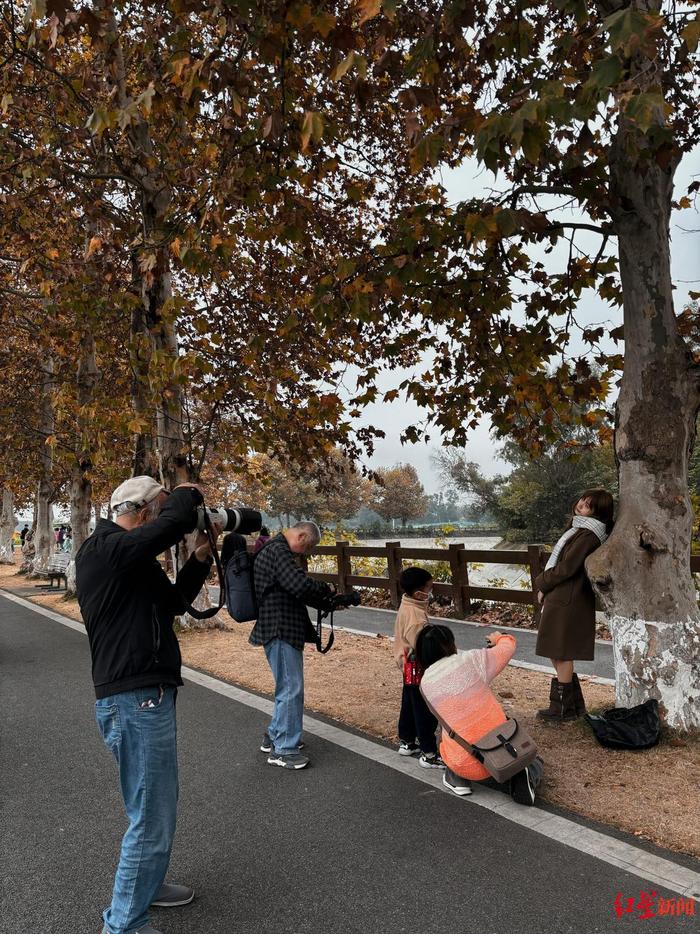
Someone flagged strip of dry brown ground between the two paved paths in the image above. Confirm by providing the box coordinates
[0,566,700,856]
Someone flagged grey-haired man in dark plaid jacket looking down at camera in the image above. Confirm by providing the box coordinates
[250,522,333,769]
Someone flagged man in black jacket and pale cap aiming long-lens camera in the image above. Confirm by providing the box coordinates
[75,477,212,934]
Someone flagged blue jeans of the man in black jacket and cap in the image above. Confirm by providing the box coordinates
[95,687,178,934]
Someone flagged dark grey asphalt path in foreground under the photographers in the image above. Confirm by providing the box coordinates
[0,597,697,934]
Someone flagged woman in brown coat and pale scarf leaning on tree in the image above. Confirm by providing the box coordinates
[535,490,613,720]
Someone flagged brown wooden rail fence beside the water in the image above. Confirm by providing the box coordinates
[311,542,700,619]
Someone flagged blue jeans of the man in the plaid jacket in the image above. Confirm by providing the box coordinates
[265,639,304,756]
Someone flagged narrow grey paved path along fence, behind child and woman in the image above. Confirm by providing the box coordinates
[211,587,615,678]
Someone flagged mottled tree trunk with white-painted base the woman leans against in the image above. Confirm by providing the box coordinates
[587,16,700,730]
